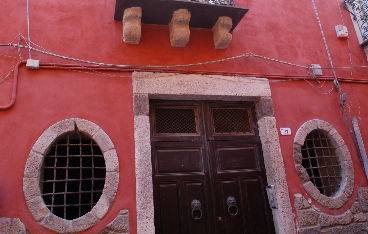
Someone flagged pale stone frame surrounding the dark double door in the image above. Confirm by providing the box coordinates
[132,72,296,234]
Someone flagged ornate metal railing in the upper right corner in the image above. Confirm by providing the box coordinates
[342,0,368,46]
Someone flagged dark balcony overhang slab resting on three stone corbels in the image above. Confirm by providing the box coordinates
[114,0,248,31]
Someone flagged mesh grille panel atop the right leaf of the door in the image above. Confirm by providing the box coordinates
[212,108,252,134]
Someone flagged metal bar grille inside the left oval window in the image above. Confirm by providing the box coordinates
[40,132,106,220]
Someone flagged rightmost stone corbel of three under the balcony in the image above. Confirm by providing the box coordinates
[212,16,233,50]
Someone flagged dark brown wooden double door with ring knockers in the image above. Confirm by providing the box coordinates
[150,100,274,234]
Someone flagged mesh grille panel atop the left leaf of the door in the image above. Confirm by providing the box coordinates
[155,108,198,134]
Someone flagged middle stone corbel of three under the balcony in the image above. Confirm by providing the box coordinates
[169,9,191,47]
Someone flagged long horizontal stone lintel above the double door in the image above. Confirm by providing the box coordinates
[133,72,271,97]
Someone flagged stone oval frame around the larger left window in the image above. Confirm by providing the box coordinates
[23,118,119,233]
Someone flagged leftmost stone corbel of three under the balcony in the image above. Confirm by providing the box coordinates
[123,7,142,44]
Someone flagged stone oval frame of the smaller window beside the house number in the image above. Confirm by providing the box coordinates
[293,119,354,209]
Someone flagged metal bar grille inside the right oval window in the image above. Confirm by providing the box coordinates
[302,130,341,196]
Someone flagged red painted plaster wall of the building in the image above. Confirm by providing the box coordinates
[0,0,368,233]
